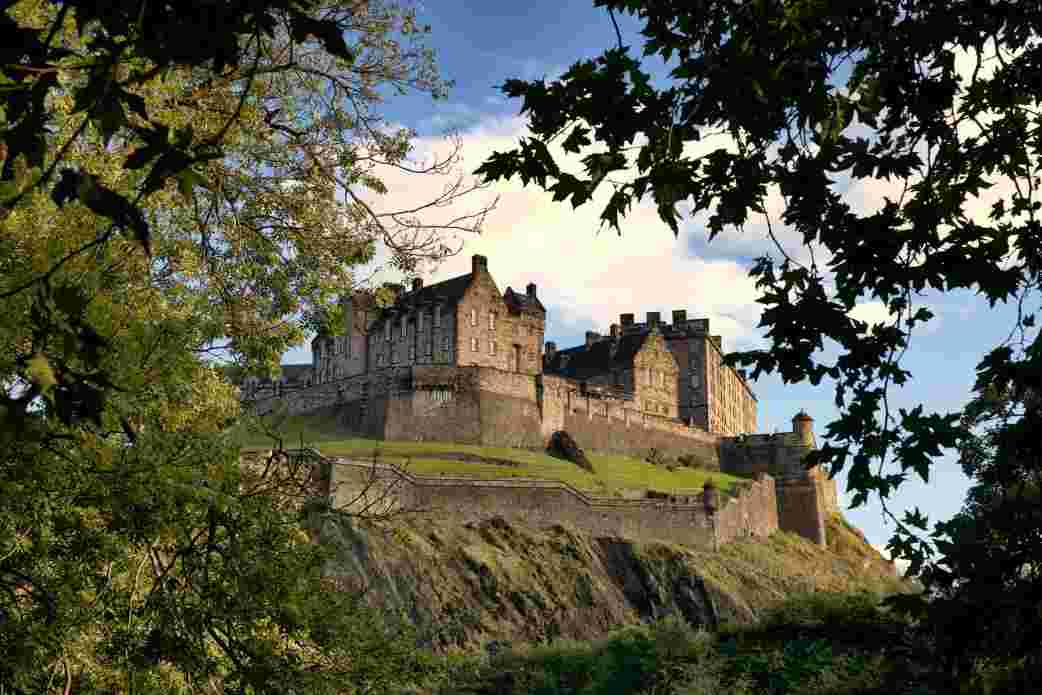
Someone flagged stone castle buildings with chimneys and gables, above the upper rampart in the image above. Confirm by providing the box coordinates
[248,255,756,435]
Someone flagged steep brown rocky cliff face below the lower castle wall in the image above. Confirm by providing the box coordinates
[323,516,909,649]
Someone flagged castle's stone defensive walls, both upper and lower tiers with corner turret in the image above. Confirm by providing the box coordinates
[253,366,838,545]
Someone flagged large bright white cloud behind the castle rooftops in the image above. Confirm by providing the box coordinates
[350,118,759,344]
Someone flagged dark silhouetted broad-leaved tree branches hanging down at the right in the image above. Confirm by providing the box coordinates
[477,0,1042,683]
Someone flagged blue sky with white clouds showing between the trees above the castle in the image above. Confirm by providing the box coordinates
[283,0,1014,566]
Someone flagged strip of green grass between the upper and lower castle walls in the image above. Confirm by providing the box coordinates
[232,416,741,495]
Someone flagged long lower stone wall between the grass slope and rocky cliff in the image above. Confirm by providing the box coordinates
[331,460,777,548]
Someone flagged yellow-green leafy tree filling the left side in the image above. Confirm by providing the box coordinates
[0,0,487,693]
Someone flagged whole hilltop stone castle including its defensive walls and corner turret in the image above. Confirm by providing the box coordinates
[241,255,838,543]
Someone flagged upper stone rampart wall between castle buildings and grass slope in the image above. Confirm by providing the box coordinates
[252,366,720,467]
